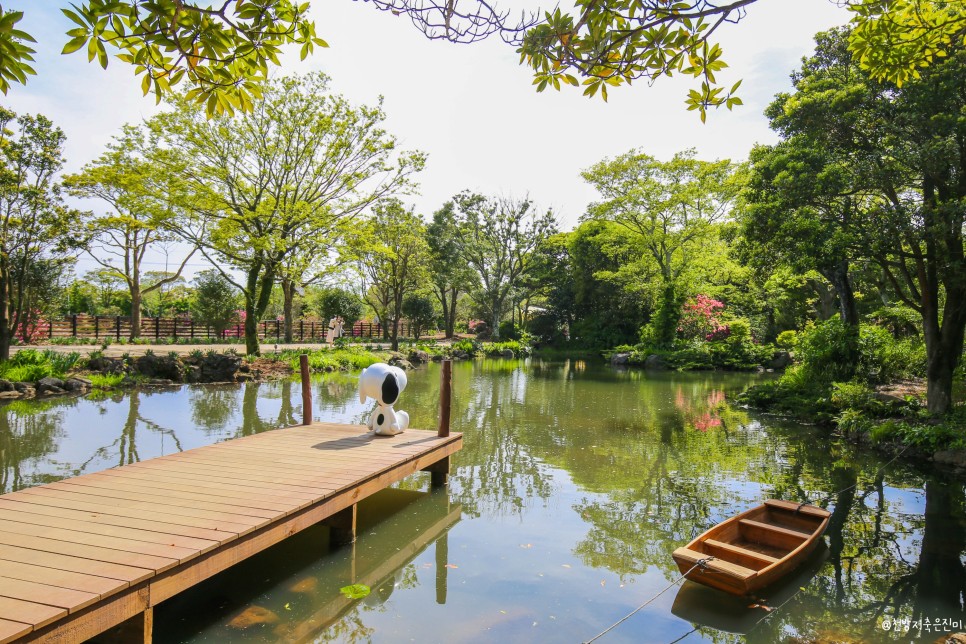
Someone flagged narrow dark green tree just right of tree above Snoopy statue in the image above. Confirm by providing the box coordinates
[426,201,476,338]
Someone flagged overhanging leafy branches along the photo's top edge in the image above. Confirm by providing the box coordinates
[0,0,966,120]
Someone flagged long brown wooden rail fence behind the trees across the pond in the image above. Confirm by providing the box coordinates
[32,315,412,342]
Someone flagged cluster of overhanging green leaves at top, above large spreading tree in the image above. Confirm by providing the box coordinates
[61,0,328,116]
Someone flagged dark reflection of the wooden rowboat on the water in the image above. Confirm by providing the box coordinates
[671,540,829,634]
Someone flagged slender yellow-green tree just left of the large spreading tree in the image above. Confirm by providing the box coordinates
[64,125,195,339]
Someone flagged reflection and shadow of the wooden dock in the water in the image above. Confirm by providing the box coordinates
[156,489,462,642]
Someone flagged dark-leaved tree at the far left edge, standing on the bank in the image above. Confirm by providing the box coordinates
[0,108,82,360]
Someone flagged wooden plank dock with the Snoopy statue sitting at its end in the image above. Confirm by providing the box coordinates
[0,423,462,644]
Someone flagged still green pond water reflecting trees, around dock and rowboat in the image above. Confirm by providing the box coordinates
[0,359,966,643]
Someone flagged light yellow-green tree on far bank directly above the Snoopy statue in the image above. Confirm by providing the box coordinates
[348,199,428,351]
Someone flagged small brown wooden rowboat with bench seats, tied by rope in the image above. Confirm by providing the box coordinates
[673,499,831,595]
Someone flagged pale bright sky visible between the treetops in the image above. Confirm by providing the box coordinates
[7,0,849,278]
